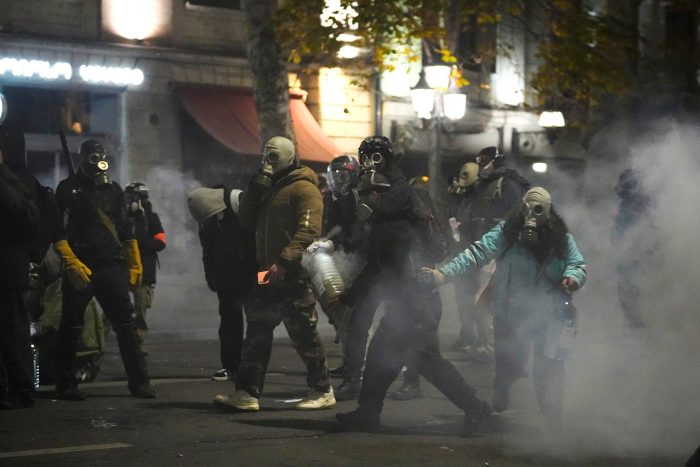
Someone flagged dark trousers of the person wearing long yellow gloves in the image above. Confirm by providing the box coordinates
[56,262,149,390]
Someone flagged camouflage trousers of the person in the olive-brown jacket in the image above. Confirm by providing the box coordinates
[236,283,331,398]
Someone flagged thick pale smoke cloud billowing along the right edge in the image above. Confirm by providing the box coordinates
[498,122,700,460]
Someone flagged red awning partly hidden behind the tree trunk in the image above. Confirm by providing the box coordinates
[175,84,342,163]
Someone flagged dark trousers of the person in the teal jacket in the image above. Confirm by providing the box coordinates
[494,319,564,425]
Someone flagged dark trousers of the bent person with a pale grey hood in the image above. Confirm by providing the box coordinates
[216,289,245,375]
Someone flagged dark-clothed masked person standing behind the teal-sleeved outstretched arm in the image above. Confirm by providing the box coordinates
[452,146,530,362]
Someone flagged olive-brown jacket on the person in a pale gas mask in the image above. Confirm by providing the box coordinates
[241,166,323,276]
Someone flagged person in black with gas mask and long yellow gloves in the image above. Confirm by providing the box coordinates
[54,140,155,401]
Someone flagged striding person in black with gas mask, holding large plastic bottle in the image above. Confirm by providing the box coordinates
[336,136,491,433]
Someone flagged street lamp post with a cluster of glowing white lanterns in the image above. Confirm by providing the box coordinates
[411,65,467,199]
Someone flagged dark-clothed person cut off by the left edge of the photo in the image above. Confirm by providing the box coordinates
[0,126,41,410]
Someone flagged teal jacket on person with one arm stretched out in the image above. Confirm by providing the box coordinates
[440,222,586,323]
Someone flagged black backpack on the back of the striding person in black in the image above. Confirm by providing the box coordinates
[411,187,450,263]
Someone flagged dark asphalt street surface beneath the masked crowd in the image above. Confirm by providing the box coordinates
[0,304,685,467]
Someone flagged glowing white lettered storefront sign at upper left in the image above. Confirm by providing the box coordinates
[0,57,144,86]
